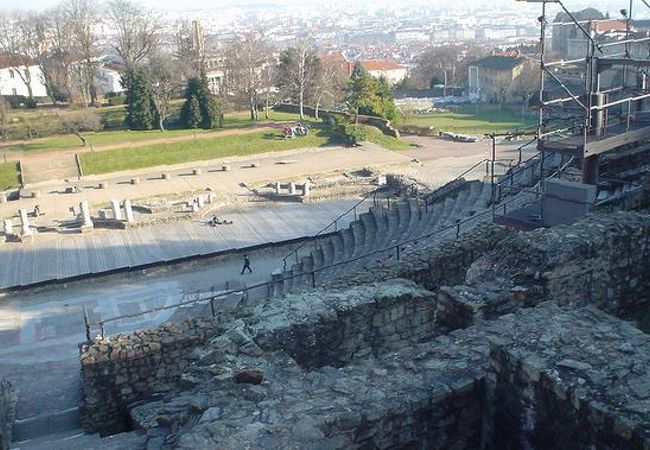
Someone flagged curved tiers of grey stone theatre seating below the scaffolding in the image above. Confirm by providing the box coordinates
[271,155,563,297]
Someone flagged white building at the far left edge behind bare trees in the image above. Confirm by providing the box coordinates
[0,55,47,97]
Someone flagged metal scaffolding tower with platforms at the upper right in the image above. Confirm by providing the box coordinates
[518,0,650,184]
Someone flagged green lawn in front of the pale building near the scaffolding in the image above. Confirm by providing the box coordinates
[402,105,536,135]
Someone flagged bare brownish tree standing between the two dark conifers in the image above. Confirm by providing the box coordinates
[148,53,180,131]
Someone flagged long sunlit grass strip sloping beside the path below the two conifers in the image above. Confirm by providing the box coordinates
[80,129,339,175]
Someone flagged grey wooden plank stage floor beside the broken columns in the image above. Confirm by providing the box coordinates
[0,200,356,289]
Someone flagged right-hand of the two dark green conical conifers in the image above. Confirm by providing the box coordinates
[181,73,223,129]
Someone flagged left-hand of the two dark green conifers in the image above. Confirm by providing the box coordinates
[123,68,156,130]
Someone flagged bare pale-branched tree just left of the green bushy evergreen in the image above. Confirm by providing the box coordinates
[278,41,321,119]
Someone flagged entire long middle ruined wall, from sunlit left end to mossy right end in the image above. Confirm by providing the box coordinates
[80,280,435,434]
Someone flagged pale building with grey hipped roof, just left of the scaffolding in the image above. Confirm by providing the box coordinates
[468,56,527,102]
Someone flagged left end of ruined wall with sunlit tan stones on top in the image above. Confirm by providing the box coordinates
[80,319,223,434]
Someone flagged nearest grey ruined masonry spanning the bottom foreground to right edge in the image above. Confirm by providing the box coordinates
[132,303,650,450]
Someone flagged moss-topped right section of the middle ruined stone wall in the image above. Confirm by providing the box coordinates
[254,280,436,370]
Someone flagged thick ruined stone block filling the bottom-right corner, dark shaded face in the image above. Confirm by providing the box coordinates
[486,310,650,450]
